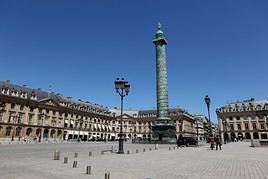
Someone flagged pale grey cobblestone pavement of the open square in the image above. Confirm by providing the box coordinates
[0,142,268,179]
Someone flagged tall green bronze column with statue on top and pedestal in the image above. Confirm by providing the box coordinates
[152,23,176,143]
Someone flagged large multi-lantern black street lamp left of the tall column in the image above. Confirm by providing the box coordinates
[114,78,130,154]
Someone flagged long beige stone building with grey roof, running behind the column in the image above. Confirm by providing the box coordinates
[0,81,195,142]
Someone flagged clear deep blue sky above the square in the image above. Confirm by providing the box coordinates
[0,0,268,122]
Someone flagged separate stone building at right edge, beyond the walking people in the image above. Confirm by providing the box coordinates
[216,98,268,141]
